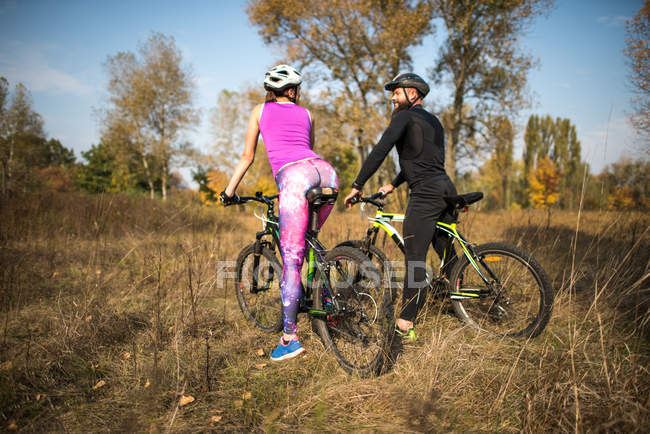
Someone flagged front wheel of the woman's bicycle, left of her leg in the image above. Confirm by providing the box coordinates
[235,243,282,332]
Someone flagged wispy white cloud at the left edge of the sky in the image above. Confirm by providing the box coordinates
[0,41,94,95]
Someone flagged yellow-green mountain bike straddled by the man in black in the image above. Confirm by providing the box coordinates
[339,192,554,338]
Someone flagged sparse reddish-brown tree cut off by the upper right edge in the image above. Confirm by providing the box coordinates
[623,0,650,142]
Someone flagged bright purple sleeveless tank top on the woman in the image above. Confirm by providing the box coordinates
[260,102,320,177]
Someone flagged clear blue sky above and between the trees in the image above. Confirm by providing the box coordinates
[0,0,647,180]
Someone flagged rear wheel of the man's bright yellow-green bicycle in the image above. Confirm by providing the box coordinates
[450,243,553,338]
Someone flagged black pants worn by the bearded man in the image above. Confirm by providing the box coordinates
[400,176,457,321]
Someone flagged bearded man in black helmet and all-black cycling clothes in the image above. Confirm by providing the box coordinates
[345,73,457,341]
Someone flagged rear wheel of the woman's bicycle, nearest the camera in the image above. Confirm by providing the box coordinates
[313,247,393,377]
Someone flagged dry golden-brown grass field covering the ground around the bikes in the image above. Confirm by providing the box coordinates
[0,195,650,432]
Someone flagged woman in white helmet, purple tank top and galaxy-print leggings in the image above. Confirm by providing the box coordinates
[221,65,338,360]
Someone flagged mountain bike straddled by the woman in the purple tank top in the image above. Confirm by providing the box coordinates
[223,188,393,376]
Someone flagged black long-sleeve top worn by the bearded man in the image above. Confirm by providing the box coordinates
[352,104,445,190]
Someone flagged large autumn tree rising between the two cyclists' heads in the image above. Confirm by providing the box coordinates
[247,0,431,190]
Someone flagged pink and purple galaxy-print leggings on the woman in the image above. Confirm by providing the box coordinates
[275,159,338,335]
